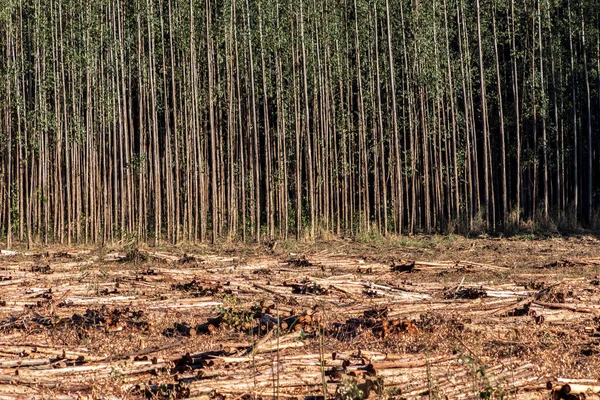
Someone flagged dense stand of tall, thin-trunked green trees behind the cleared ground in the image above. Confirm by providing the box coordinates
[0,0,600,245]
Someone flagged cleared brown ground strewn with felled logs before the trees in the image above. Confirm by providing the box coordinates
[0,235,600,399]
